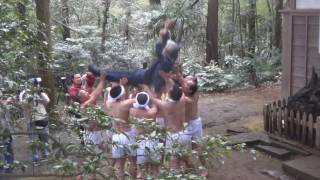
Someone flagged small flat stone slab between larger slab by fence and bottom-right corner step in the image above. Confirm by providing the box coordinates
[254,145,290,160]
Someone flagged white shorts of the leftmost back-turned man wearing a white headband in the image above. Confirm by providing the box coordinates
[112,128,137,158]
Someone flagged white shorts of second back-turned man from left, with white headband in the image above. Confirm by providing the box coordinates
[137,139,162,165]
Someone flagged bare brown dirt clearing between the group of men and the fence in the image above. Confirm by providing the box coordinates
[199,85,280,134]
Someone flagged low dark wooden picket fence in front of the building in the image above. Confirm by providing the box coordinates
[263,99,320,150]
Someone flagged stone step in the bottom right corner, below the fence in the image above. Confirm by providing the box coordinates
[282,155,320,180]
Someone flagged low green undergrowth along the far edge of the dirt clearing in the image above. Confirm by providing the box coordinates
[183,50,280,91]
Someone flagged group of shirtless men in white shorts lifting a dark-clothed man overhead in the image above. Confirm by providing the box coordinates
[69,21,205,179]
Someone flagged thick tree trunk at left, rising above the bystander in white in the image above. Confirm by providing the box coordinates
[35,0,55,110]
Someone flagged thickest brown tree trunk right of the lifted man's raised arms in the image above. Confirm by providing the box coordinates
[206,0,219,64]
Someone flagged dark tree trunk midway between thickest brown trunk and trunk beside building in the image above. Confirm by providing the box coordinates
[248,0,257,57]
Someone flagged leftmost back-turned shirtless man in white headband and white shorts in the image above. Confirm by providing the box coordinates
[105,85,137,179]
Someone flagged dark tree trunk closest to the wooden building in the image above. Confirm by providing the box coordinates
[272,0,283,49]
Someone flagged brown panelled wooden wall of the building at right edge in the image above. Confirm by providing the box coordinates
[282,9,320,97]
